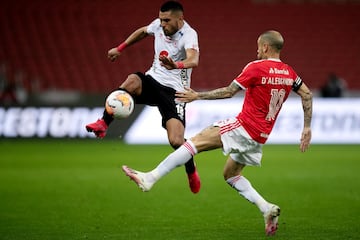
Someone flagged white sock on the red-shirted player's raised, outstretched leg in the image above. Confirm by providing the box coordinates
[149,140,197,182]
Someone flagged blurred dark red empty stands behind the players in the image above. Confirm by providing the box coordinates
[0,0,360,105]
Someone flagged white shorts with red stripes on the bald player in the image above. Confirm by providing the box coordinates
[213,118,262,166]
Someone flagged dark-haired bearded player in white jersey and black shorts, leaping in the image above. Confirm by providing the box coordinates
[86,1,200,193]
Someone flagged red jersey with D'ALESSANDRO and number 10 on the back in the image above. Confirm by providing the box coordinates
[234,59,302,143]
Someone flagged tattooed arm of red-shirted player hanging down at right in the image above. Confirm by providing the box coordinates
[296,83,312,152]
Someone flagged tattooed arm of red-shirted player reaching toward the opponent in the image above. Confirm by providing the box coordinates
[175,82,241,102]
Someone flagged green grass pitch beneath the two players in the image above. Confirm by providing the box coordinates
[0,139,360,240]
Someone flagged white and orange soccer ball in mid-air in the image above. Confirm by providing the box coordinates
[105,90,135,119]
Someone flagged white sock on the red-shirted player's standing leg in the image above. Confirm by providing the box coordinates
[226,175,269,213]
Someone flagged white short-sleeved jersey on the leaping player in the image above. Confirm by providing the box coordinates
[146,19,199,91]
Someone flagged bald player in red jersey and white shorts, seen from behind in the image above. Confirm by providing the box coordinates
[123,30,312,235]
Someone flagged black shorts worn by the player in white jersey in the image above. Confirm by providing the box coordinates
[134,72,186,128]
